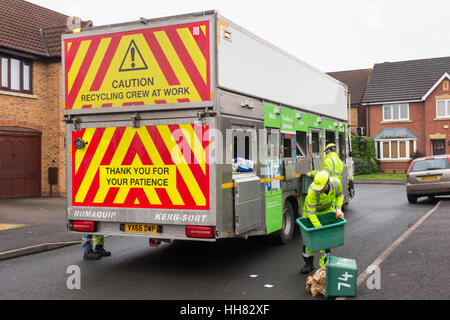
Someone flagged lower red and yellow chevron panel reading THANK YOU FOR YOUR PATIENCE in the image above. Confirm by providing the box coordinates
[72,124,209,210]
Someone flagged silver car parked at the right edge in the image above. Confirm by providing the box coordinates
[406,155,450,203]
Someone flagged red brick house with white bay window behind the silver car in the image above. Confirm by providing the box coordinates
[362,57,450,172]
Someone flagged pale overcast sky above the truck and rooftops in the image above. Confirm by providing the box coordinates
[29,0,450,72]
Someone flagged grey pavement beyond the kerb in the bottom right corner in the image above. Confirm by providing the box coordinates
[354,198,450,300]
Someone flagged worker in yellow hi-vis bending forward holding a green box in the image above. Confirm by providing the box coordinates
[300,170,344,273]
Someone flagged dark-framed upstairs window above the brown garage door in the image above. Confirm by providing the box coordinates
[0,56,32,93]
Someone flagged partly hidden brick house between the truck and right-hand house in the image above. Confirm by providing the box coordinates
[328,69,372,130]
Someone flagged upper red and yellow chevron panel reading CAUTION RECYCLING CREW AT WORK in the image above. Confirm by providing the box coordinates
[64,21,213,109]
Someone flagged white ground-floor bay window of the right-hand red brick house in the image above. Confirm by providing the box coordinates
[375,139,416,160]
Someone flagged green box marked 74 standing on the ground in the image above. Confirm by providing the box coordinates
[325,254,358,298]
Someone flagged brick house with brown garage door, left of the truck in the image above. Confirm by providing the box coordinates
[0,0,91,199]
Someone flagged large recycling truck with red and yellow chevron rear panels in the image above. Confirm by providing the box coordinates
[62,11,352,243]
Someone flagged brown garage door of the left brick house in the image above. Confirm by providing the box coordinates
[0,131,41,199]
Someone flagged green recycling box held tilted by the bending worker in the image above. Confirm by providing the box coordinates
[296,211,347,252]
